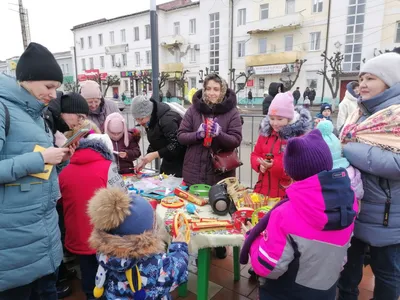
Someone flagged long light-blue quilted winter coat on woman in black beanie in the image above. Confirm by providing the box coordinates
[0,75,62,291]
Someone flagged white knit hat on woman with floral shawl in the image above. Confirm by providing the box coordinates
[360,53,400,87]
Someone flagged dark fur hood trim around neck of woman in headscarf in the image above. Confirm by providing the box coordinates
[192,88,237,115]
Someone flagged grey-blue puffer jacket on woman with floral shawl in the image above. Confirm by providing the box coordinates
[343,83,400,247]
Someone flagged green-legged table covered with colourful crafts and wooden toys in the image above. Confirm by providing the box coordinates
[123,177,274,300]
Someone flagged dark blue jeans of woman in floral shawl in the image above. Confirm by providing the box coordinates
[338,237,400,300]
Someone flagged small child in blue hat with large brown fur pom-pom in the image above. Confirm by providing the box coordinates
[88,189,189,300]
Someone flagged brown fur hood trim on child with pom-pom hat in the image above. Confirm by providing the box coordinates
[89,229,165,265]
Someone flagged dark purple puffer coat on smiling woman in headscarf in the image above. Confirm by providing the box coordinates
[178,89,242,186]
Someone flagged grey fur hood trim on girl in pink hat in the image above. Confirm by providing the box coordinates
[260,107,312,140]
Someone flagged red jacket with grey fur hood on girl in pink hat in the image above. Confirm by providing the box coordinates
[251,109,312,198]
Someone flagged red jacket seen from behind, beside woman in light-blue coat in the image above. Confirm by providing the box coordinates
[59,140,124,255]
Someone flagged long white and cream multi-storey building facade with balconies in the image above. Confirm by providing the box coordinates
[72,0,400,103]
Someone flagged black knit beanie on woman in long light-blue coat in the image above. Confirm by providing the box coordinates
[16,43,63,83]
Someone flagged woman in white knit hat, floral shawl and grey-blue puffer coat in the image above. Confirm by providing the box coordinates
[339,53,400,300]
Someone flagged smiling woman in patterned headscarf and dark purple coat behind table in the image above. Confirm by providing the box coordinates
[178,74,242,186]
